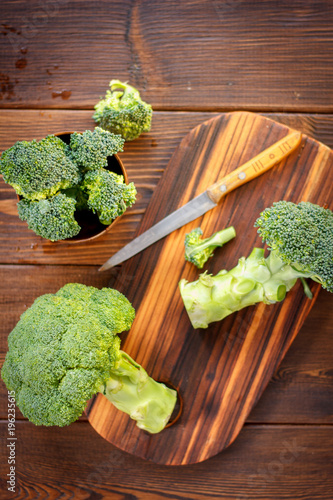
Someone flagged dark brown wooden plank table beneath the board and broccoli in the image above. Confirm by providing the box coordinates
[0,0,333,500]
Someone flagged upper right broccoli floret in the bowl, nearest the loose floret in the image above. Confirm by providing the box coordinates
[70,127,125,170]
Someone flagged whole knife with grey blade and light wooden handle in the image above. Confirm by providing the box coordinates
[99,131,302,271]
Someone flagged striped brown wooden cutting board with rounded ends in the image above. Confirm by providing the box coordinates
[88,112,333,465]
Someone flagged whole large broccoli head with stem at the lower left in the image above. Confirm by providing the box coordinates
[1,283,176,433]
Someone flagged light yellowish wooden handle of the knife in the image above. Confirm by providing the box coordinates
[206,131,302,203]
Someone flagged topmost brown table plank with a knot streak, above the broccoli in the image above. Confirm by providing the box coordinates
[0,0,333,112]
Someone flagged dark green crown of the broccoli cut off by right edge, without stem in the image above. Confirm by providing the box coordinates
[255,201,333,292]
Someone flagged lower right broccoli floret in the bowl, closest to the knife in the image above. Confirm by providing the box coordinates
[82,168,136,225]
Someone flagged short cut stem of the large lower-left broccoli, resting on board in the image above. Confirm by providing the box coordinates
[100,351,177,434]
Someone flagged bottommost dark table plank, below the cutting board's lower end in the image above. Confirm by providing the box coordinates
[0,422,333,500]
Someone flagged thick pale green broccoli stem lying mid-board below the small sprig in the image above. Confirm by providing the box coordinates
[179,248,310,328]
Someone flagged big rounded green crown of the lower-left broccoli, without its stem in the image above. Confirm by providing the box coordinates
[1,283,135,427]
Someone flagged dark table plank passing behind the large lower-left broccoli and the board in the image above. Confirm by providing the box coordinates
[0,265,333,424]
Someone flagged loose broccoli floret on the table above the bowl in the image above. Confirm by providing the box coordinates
[93,80,153,141]
